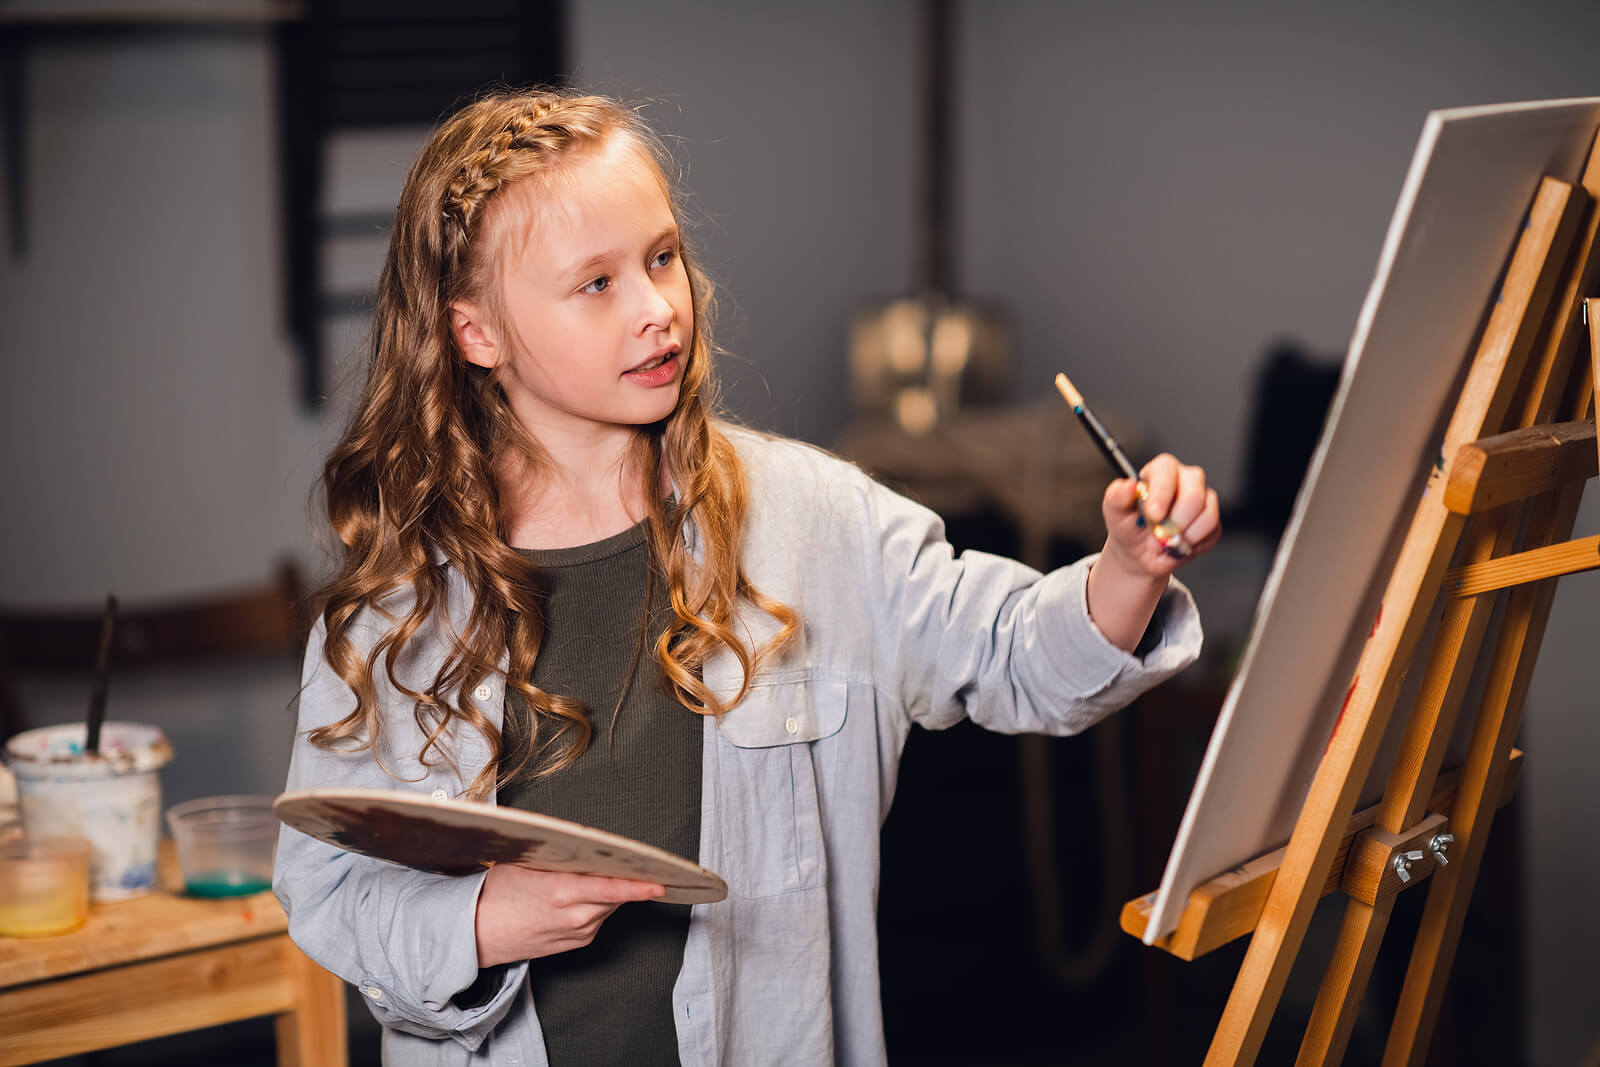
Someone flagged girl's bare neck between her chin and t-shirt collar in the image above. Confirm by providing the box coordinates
[501,422,648,549]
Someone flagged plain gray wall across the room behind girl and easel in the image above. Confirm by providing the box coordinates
[0,0,1600,1064]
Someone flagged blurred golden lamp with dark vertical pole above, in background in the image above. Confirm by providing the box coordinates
[850,0,1011,435]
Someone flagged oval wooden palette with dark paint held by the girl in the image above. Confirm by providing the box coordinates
[272,789,728,904]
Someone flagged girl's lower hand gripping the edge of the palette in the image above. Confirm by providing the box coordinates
[475,864,666,968]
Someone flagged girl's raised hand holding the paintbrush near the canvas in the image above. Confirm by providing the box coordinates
[1101,453,1222,577]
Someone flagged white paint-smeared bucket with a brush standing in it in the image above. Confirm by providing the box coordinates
[5,723,173,901]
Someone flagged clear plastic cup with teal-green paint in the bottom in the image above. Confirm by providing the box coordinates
[166,797,278,896]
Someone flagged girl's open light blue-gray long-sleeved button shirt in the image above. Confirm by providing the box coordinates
[274,427,1200,1067]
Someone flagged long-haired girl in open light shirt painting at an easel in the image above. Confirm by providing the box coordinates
[275,93,1221,1067]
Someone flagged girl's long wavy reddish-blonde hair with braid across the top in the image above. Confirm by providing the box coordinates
[310,91,798,798]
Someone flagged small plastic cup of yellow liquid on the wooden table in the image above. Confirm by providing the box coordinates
[0,837,93,937]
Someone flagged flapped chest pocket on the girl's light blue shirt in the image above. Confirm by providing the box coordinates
[714,678,845,897]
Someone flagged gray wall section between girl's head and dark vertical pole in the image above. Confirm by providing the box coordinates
[573,0,915,442]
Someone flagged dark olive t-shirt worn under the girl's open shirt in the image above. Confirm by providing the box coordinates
[499,523,704,1067]
